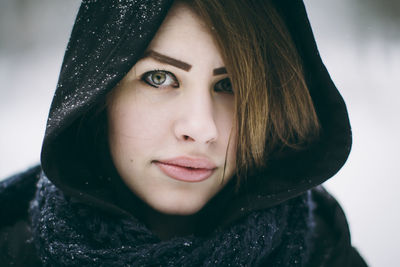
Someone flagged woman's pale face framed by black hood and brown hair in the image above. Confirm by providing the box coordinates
[108,4,236,215]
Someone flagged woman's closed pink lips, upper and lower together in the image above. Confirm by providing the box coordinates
[154,157,216,182]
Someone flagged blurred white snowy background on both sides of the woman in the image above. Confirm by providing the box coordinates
[0,0,400,267]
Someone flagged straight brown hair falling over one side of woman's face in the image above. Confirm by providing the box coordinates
[186,0,319,182]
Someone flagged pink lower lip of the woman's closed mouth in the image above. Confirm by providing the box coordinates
[155,162,214,182]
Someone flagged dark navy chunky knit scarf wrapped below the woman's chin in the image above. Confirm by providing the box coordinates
[30,175,313,266]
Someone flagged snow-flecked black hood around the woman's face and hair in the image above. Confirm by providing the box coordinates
[41,0,351,228]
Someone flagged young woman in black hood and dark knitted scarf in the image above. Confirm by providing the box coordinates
[0,0,365,266]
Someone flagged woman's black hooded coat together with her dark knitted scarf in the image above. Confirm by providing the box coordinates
[0,0,366,267]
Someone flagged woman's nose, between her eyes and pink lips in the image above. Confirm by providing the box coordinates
[173,90,218,144]
